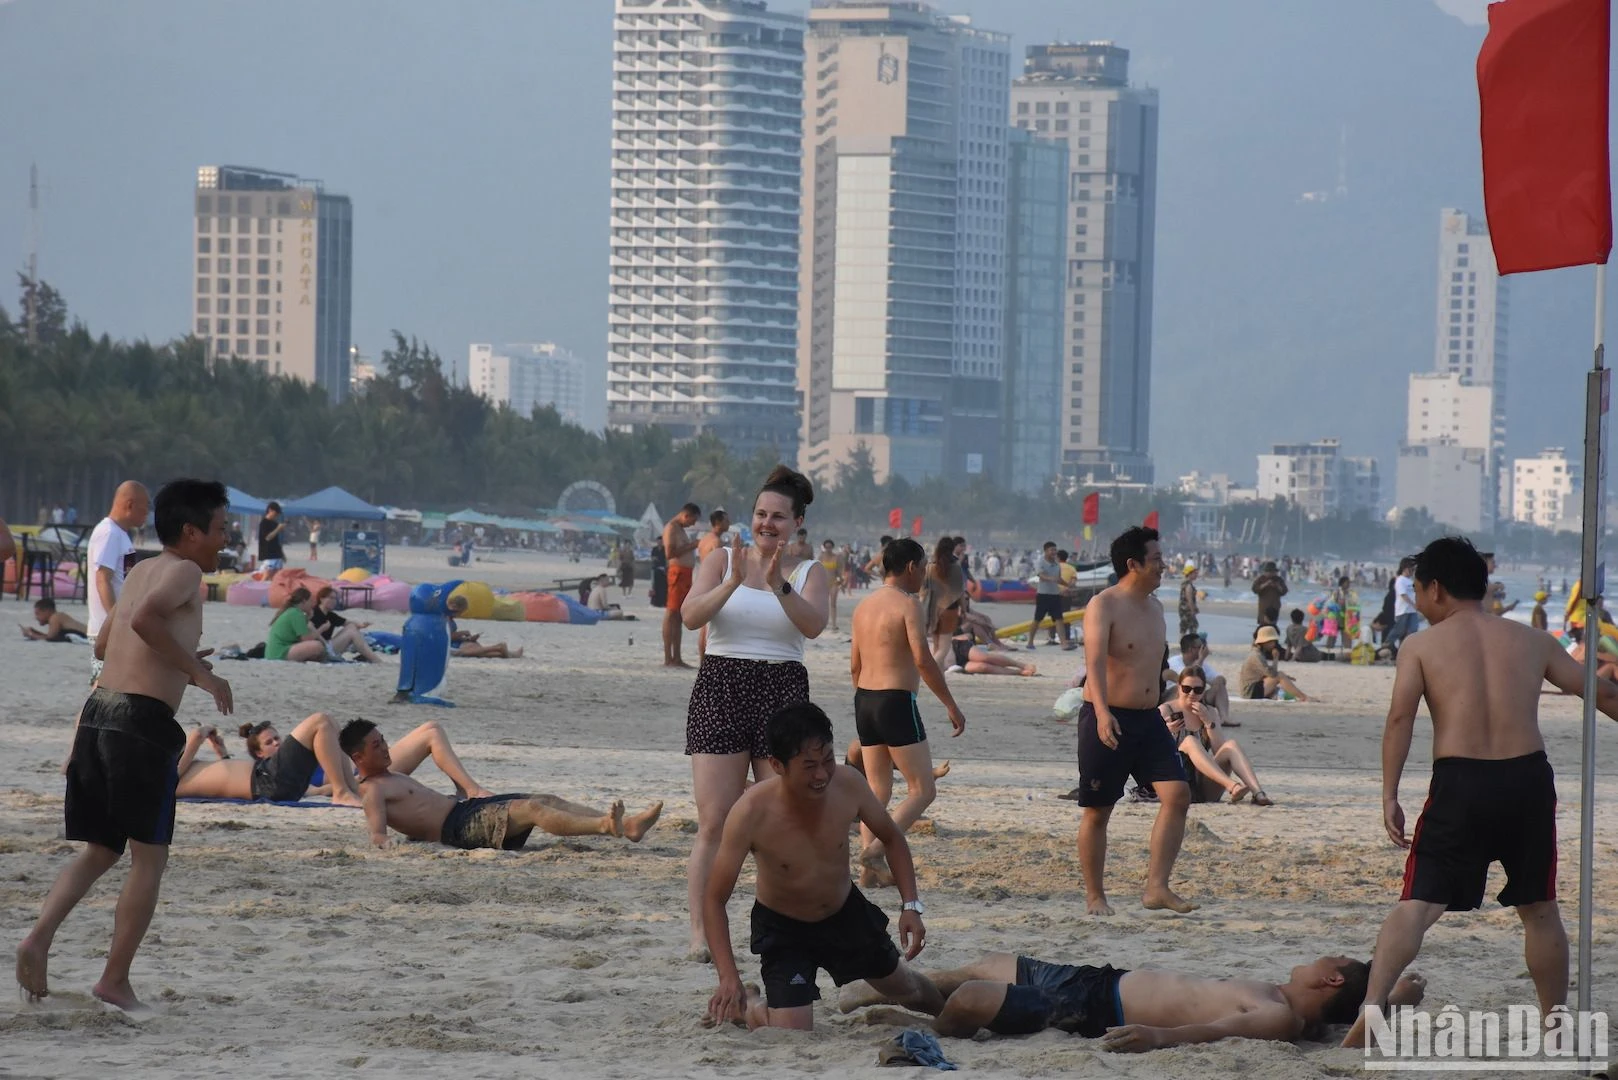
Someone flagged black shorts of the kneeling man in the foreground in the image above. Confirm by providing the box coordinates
[752,886,900,1009]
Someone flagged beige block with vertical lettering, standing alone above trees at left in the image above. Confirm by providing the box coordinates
[193,165,354,402]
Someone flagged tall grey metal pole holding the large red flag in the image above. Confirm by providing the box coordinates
[1578,262,1610,1012]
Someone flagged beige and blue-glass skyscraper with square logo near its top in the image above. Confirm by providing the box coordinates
[798,0,1011,481]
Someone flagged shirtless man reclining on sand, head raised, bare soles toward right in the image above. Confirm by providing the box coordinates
[341,721,663,852]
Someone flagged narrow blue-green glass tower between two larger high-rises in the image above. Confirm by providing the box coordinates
[1000,128,1068,494]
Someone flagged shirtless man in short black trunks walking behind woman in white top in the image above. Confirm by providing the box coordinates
[848,536,966,889]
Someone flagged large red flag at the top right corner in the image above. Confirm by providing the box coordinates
[1477,0,1613,274]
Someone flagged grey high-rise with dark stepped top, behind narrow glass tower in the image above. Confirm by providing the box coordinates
[1011,42,1157,483]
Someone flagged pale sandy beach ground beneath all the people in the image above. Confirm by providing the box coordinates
[0,549,1618,1080]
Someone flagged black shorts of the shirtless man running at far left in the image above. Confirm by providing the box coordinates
[63,690,186,855]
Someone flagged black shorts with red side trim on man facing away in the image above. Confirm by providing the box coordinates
[1400,750,1557,912]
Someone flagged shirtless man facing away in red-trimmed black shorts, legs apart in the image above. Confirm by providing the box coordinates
[1343,536,1618,1046]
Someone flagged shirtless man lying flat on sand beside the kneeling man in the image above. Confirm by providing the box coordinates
[837,952,1427,1051]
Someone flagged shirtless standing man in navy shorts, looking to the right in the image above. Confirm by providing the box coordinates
[1079,526,1197,915]
